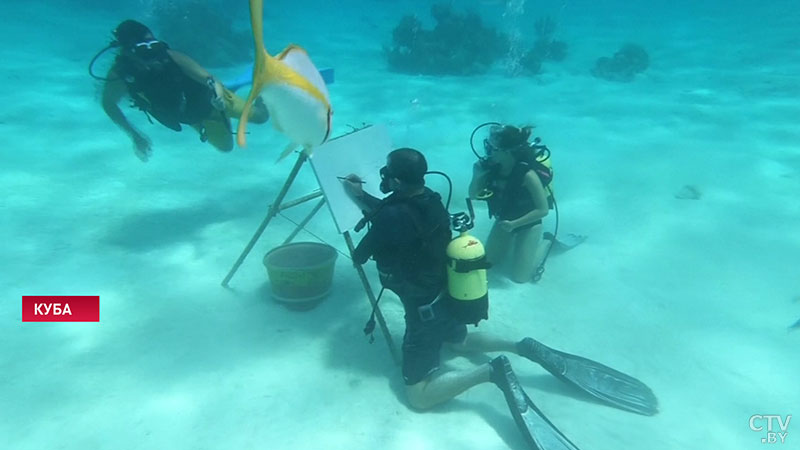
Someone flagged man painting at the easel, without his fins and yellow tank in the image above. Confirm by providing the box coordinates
[344,148,515,409]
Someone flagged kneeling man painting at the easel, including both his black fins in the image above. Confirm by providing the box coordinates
[342,148,658,450]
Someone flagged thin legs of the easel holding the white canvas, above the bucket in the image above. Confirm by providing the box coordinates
[222,135,400,365]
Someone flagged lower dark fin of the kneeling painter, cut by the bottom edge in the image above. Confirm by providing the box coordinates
[489,355,580,450]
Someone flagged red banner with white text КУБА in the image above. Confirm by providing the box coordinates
[22,295,100,322]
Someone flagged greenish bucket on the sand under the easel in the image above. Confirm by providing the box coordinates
[264,242,337,309]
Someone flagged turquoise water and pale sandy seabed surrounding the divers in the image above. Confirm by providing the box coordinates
[0,0,800,450]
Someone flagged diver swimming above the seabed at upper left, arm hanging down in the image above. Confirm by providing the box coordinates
[89,20,269,161]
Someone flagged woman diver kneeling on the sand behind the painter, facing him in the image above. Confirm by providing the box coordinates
[469,122,586,283]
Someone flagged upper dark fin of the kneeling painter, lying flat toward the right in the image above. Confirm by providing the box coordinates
[517,337,658,416]
